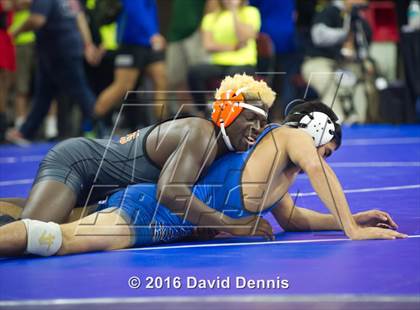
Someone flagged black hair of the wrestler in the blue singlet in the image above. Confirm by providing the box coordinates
[283,100,342,150]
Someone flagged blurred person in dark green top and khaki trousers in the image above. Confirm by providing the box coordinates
[166,0,217,111]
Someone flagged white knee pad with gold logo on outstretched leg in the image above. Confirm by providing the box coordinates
[22,219,63,256]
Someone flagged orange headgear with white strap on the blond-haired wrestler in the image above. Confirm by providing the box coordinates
[211,88,267,128]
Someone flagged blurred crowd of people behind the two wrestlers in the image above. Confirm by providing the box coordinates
[0,0,420,145]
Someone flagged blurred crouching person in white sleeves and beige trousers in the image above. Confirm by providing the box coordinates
[302,0,374,123]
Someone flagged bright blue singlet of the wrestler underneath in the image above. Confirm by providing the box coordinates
[98,124,280,247]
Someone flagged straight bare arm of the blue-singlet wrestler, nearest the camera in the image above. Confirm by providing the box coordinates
[286,130,405,239]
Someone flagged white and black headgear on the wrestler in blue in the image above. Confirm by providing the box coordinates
[284,99,341,147]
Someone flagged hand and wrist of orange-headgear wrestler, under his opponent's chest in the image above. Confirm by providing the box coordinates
[225,216,275,240]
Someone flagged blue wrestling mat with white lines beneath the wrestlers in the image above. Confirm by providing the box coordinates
[0,126,420,310]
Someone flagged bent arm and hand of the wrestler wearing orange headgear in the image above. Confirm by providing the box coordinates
[157,124,272,238]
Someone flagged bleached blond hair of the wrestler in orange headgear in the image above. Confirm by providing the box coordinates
[216,73,276,108]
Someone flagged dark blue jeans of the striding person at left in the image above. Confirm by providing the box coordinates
[20,52,96,138]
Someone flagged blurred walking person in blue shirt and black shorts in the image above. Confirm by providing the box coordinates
[95,0,167,123]
